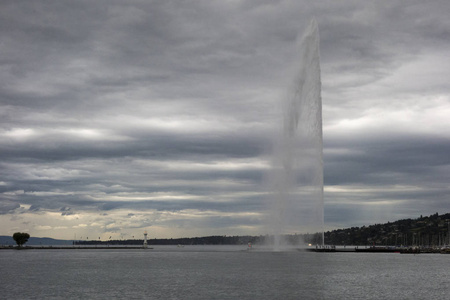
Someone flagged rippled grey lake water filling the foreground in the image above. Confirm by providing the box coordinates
[0,246,450,300]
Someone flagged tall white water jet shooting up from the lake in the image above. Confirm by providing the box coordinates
[271,20,324,250]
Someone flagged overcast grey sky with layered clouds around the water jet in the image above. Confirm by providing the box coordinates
[0,0,450,239]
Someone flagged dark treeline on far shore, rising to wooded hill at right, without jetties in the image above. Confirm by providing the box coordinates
[73,213,450,246]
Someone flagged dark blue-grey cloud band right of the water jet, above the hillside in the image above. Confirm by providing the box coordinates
[324,135,450,185]
